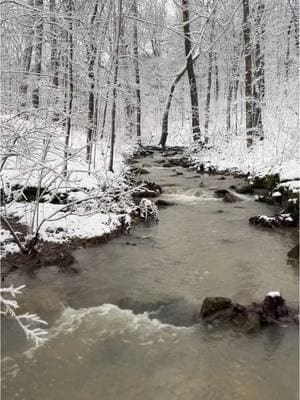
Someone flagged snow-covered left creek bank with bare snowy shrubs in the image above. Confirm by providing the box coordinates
[1,117,139,256]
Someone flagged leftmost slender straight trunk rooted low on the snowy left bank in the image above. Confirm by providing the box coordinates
[63,0,74,176]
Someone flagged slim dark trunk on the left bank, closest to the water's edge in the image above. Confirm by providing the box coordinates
[109,0,122,172]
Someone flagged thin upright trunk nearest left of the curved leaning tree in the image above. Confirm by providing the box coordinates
[133,0,142,145]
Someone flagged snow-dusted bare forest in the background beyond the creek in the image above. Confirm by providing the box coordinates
[1,0,299,155]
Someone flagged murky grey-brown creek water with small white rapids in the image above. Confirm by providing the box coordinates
[2,155,298,400]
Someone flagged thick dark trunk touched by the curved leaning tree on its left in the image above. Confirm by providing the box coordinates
[182,0,201,141]
